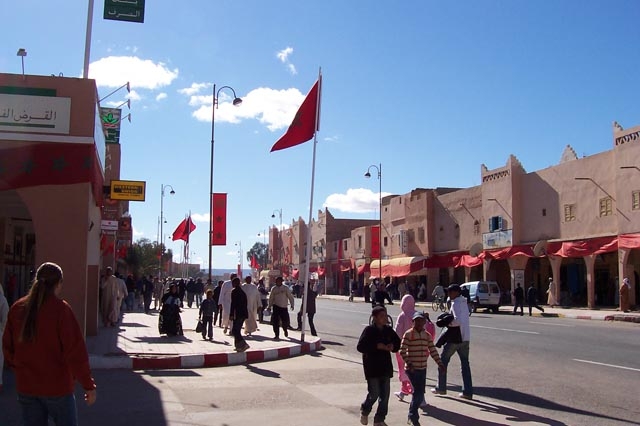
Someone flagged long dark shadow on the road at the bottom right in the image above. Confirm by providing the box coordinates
[476,387,636,425]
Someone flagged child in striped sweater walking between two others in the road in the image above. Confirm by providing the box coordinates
[398,312,446,426]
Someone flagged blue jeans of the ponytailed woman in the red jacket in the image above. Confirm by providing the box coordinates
[18,393,78,426]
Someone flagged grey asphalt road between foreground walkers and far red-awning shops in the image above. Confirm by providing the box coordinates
[315,299,640,425]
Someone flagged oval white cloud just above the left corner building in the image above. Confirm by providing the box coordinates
[89,56,179,90]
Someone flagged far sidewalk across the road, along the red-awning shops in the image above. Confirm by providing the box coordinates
[318,294,640,324]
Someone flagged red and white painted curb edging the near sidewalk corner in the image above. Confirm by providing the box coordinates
[89,339,322,370]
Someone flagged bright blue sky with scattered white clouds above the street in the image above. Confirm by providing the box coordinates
[0,0,640,268]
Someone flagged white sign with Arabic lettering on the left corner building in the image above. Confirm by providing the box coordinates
[0,93,71,135]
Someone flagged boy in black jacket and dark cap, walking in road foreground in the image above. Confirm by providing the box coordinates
[357,306,400,426]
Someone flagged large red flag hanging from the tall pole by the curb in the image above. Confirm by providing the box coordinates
[271,78,322,152]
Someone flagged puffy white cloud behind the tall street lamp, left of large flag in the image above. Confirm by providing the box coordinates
[180,83,305,131]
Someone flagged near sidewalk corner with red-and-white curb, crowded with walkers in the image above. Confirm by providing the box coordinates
[87,305,322,370]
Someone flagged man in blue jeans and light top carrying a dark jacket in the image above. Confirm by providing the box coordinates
[431,284,473,399]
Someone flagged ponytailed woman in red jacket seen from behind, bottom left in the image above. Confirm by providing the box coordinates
[2,262,96,426]
